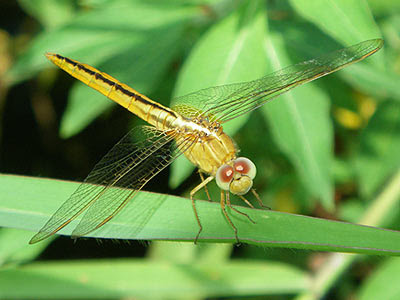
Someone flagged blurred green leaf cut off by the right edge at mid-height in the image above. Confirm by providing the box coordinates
[355,102,400,198]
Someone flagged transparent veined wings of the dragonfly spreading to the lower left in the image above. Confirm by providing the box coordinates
[30,126,194,244]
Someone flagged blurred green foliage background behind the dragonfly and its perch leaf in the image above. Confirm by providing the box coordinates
[0,0,400,299]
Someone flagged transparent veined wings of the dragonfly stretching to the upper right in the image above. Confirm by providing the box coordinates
[173,39,383,123]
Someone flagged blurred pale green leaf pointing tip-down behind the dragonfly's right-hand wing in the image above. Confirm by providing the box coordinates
[262,34,333,210]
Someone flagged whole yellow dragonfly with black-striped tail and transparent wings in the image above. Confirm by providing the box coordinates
[30,39,383,244]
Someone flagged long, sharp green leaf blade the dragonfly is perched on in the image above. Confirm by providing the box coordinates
[0,175,400,255]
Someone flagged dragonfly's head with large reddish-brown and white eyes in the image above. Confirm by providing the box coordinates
[215,157,257,195]
